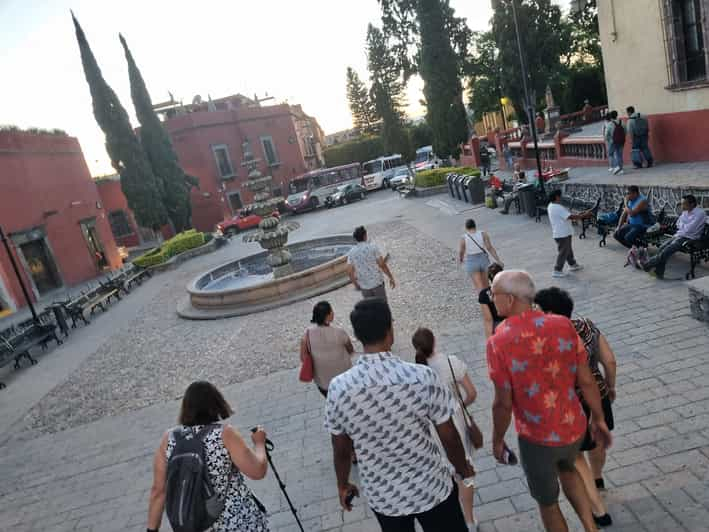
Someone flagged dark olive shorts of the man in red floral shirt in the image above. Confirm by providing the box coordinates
[519,437,583,506]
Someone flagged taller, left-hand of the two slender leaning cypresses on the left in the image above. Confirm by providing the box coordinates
[71,13,167,228]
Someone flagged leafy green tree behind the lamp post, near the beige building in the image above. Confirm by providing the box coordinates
[490,0,572,122]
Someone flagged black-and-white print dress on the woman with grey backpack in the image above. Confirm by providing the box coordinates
[165,425,269,532]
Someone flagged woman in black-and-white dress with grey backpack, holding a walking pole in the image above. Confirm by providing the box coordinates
[147,381,269,532]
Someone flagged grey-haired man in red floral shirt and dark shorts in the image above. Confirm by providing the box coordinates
[487,271,611,531]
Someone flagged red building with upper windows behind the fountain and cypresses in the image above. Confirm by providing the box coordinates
[156,95,324,231]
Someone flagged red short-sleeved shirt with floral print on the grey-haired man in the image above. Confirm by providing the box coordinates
[487,310,587,446]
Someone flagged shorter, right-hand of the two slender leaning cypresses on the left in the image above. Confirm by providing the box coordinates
[119,35,198,233]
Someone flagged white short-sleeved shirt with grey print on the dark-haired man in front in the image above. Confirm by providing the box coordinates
[325,353,455,516]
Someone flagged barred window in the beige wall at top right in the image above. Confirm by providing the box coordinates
[662,0,709,89]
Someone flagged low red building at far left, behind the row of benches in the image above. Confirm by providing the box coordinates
[0,131,121,316]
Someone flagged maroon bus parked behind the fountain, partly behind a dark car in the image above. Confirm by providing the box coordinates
[286,163,362,212]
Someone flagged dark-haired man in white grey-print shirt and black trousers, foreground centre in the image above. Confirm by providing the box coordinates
[325,299,475,532]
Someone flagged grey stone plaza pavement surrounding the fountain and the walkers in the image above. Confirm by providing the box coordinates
[0,193,709,532]
